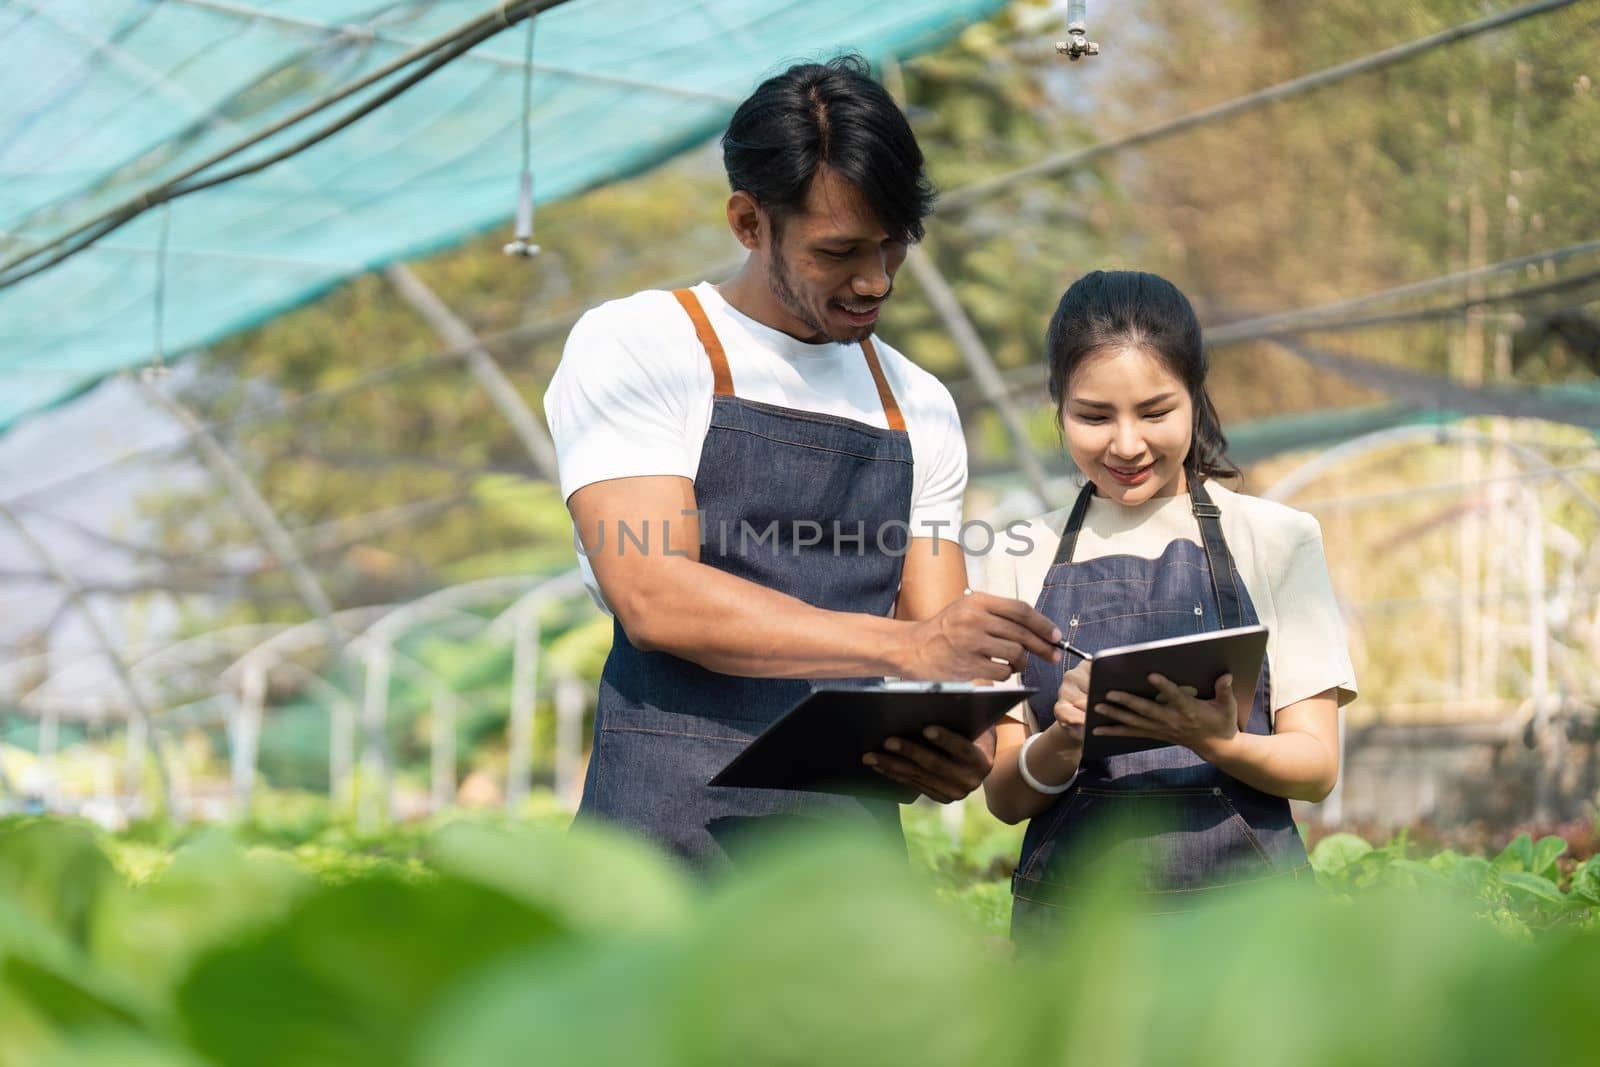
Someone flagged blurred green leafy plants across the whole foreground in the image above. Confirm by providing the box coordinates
[0,811,1600,1067]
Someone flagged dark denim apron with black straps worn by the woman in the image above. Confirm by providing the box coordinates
[1011,475,1309,934]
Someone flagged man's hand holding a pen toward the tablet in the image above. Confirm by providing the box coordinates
[901,593,1061,684]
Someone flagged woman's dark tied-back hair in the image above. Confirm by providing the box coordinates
[1045,270,1238,478]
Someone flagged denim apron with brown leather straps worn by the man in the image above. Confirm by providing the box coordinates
[578,290,912,870]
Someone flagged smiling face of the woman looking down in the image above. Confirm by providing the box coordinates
[1061,346,1195,506]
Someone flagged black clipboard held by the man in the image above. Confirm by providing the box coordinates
[709,681,1034,803]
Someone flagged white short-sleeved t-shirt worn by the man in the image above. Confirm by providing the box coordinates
[544,282,966,606]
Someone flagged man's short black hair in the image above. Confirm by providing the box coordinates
[722,54,934,243]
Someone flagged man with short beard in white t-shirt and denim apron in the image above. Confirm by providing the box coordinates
[546,58,1059,867]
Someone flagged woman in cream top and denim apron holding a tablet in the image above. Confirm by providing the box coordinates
[986,270,1355,933]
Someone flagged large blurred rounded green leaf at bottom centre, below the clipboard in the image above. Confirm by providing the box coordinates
[677,837,1024,1067]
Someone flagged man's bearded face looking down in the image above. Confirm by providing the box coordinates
[766,166,906,344]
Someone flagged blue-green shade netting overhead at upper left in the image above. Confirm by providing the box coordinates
[0,0,1005,432]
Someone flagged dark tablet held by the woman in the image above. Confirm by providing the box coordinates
[1083,625,1267,761]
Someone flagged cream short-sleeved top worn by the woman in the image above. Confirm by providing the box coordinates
[979,482,1355,729]
